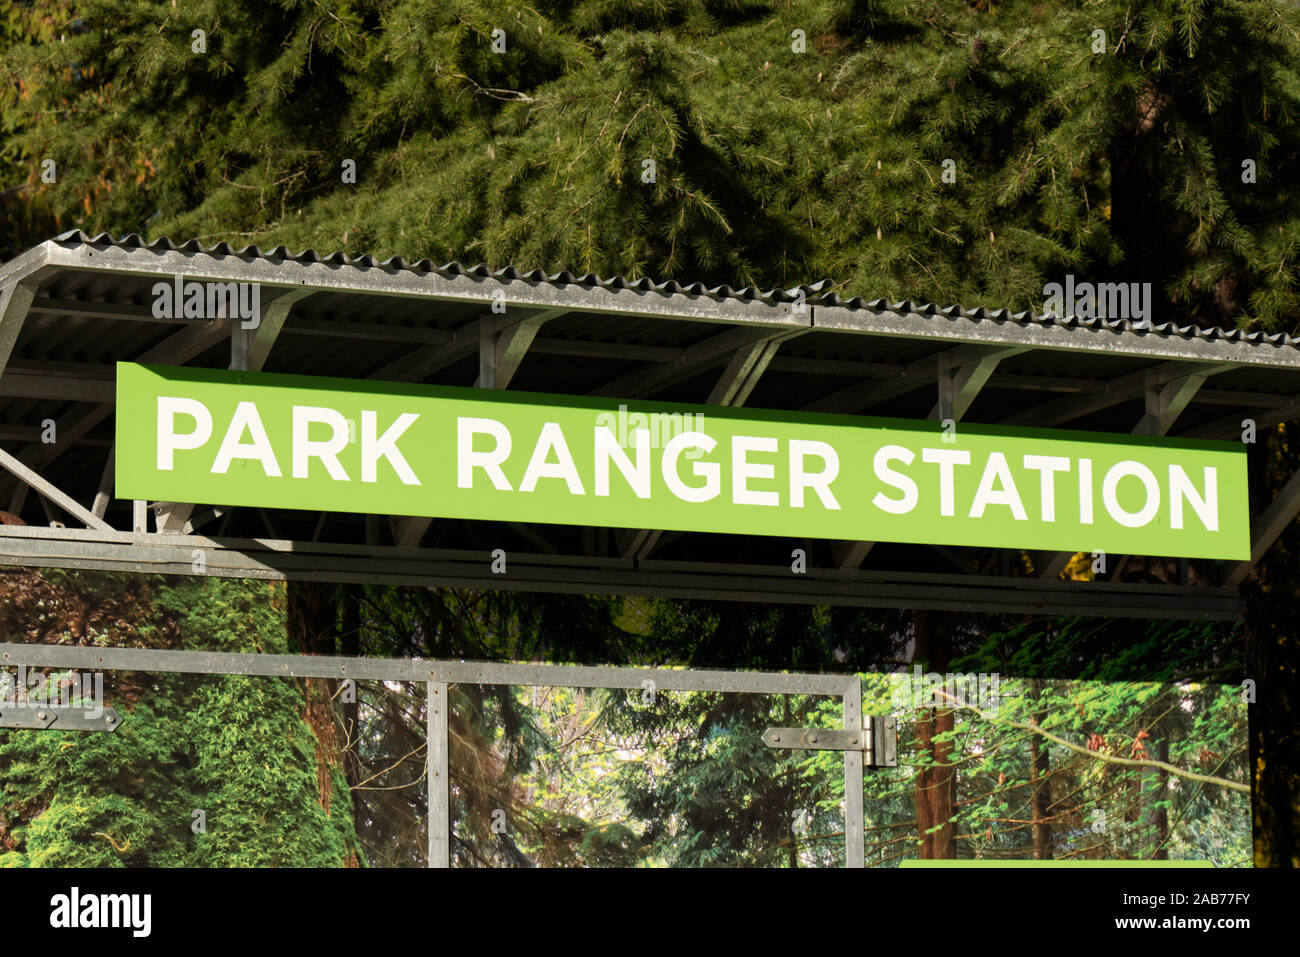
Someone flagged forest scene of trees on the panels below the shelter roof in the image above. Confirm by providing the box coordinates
[0,570,1252,867]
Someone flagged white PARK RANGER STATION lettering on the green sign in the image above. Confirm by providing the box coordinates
[150,395,1223,532]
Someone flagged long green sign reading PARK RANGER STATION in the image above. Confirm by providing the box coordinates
[117,363,1251,559]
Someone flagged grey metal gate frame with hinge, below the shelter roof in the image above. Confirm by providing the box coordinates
[0,642,896,867]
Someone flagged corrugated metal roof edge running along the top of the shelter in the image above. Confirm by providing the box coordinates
[0,230,1300,358]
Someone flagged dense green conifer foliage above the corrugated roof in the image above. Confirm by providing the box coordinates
[0,0,1300,328]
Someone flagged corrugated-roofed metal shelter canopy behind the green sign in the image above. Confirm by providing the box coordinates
[0,231,1300,619]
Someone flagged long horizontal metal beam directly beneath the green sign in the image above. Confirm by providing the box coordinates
[0,525,1242,619]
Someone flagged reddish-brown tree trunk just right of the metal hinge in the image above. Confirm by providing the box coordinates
[913,611,957,859]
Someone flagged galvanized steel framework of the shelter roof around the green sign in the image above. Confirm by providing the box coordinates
[0,233,1300,618]
